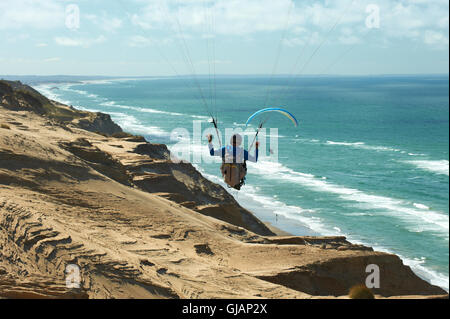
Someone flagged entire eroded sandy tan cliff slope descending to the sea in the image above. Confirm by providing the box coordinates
[0,82,445,298]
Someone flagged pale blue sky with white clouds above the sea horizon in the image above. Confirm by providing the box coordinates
[0,0,449,76]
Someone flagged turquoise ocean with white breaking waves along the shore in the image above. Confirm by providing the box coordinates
[35,75,449,291]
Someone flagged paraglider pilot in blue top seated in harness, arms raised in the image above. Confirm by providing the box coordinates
[207,134,259,190]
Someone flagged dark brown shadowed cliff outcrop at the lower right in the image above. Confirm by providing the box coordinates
[251,241,445,297]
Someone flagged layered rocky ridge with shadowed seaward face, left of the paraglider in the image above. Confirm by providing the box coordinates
[55,134,274,235]
